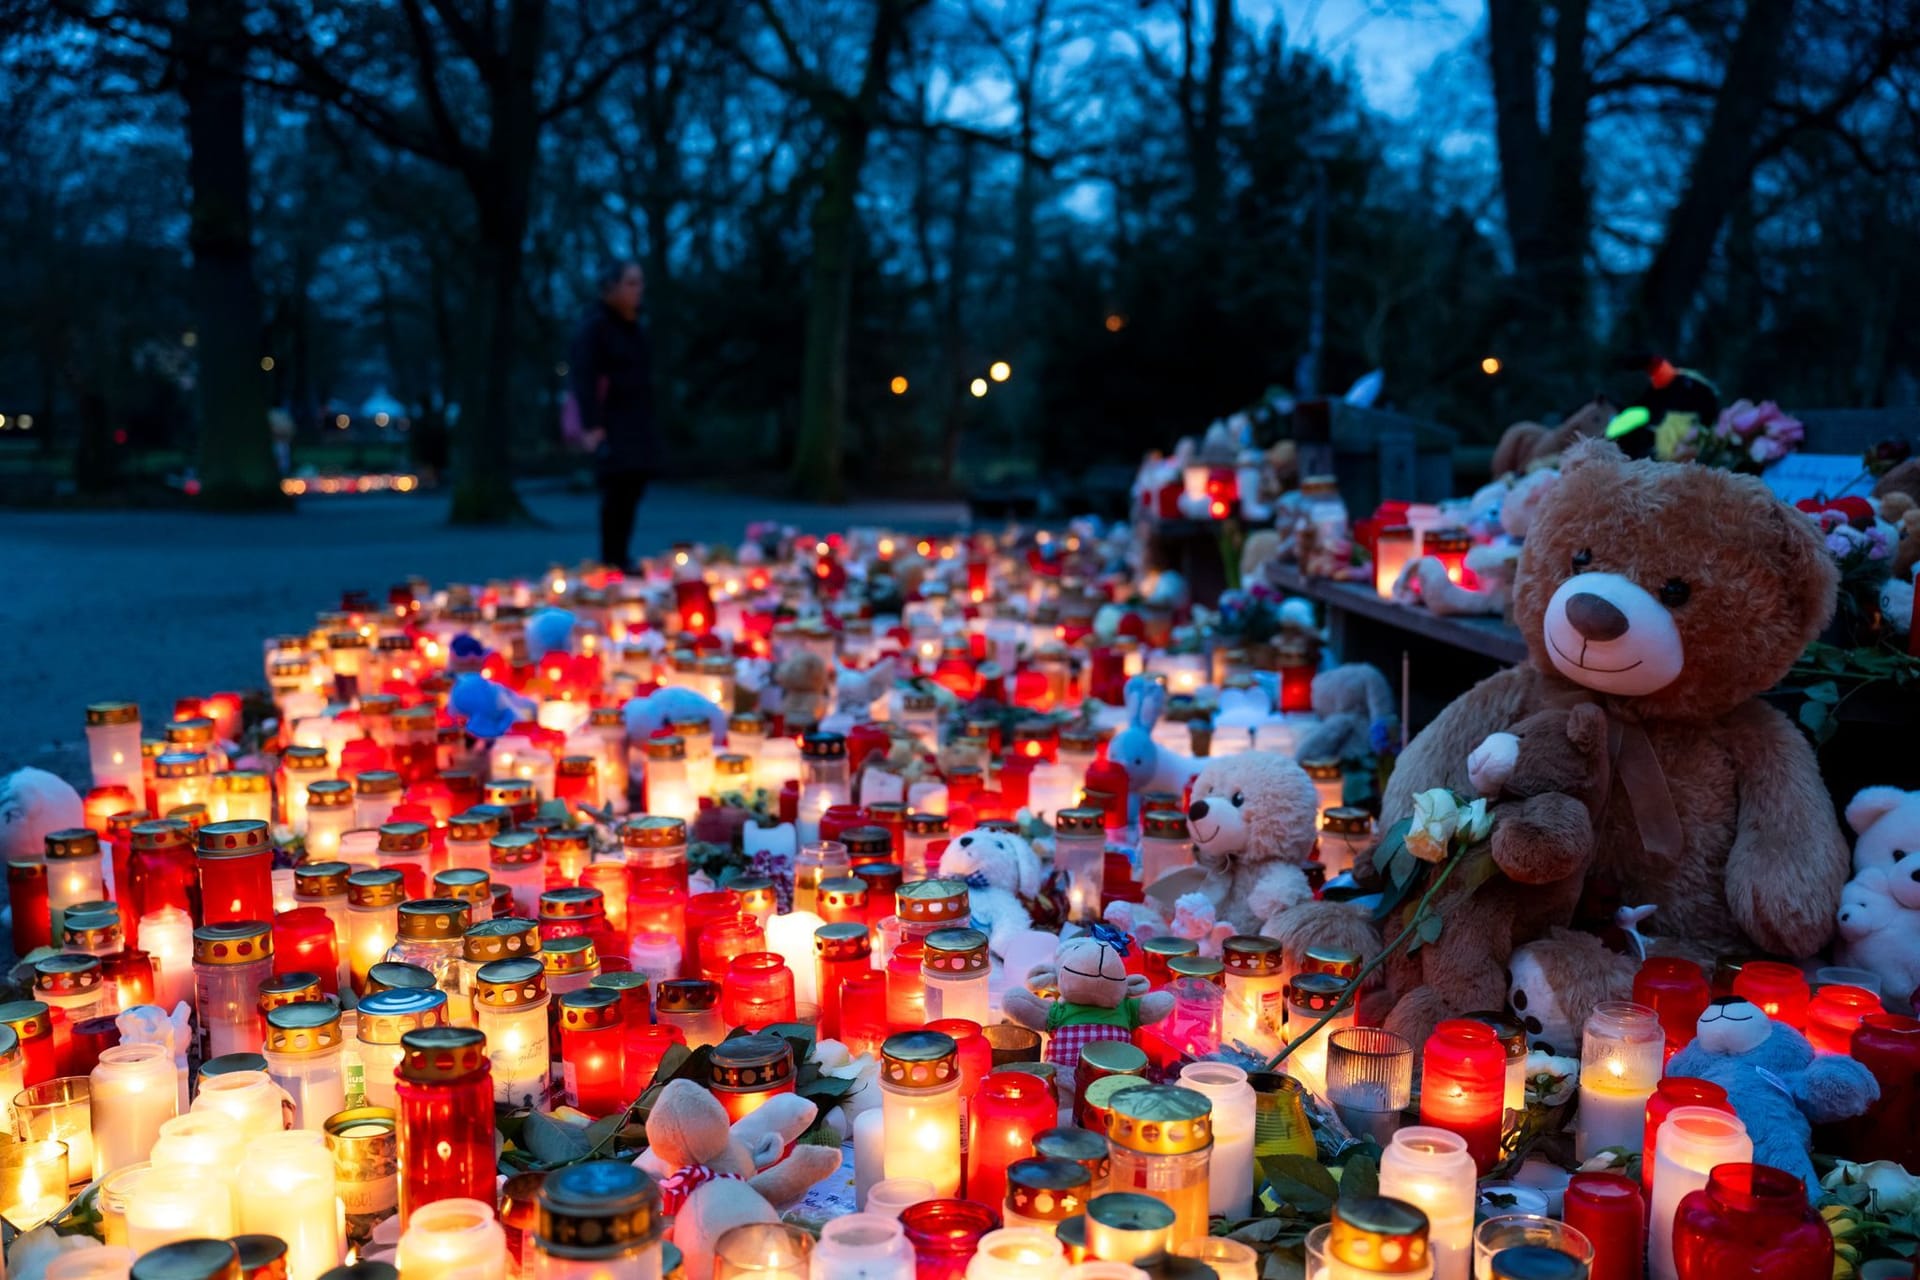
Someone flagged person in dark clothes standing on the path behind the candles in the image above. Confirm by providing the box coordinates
[568,261,659,570]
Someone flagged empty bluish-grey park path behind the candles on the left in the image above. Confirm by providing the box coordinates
[0,486,966,787]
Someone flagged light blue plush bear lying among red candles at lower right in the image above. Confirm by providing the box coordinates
[1667,996,1880,1199]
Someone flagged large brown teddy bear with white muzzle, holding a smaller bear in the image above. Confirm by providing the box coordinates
[1292,441,1847,1043]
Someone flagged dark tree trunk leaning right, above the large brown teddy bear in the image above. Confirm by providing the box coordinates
[1622,0,1793,351]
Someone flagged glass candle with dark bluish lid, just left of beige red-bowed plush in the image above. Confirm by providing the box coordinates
[528,1159,666,1280]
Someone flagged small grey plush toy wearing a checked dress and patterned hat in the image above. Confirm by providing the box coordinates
[1004,925,1173,1088]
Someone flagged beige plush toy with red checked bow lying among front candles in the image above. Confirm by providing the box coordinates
[634,1080,841,1280]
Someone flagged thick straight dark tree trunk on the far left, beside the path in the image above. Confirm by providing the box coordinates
[180,0,290,509]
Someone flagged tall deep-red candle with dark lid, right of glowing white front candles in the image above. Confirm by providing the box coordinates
[396,1027,495,1224]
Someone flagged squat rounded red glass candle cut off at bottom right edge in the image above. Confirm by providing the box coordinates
[1674,1159,1834,1280]
